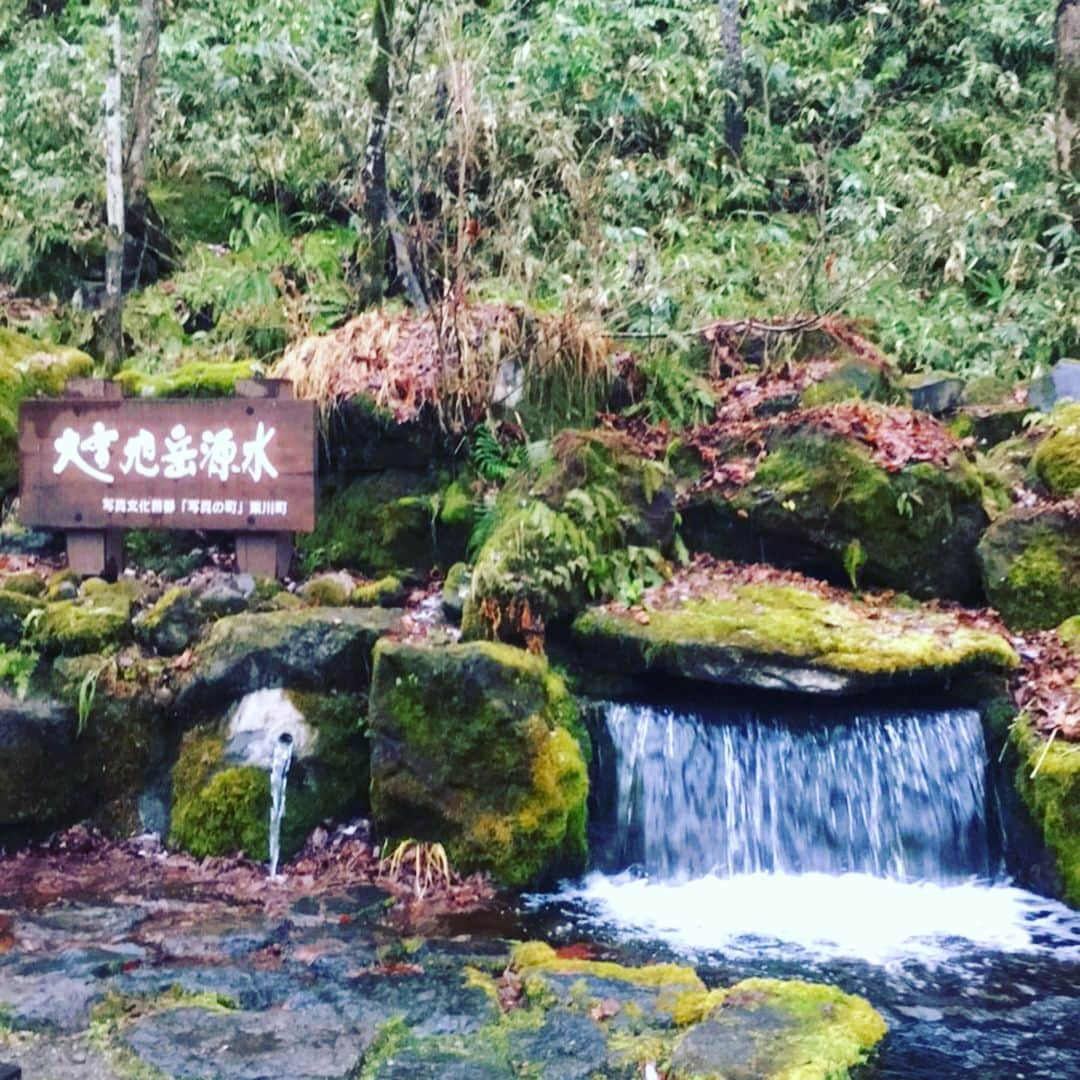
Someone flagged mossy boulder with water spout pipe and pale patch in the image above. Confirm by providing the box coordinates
[170,690,369,861]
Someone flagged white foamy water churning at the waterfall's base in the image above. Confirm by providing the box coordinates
[561,873,1080,963]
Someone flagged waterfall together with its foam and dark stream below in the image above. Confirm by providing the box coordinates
[537,703,1080,1080]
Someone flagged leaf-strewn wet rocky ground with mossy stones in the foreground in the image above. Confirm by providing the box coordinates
[0,831,885,1080]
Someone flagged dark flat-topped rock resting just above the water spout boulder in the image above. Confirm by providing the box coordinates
[177,607,401,715]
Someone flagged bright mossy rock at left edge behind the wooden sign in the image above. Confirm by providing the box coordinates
[0,326,94,494]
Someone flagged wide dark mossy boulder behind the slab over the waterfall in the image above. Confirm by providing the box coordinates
[681,428,988,600]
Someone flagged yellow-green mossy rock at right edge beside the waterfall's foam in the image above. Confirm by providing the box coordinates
[1010,716,1080,908]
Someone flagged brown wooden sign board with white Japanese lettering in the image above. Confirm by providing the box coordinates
[18,388,316,578]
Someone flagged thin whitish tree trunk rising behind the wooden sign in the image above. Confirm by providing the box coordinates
[104,15,124,372]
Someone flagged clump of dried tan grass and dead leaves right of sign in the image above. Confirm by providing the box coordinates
[273,301,611,431]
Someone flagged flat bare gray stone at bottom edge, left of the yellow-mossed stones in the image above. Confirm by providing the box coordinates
[124,1005,375,1080]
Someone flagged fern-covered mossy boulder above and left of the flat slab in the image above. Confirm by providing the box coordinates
[461,431,674,644]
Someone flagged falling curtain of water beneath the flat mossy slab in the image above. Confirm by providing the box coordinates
[604,704,996,885]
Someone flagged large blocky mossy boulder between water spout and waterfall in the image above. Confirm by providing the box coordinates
[368,640,589,887]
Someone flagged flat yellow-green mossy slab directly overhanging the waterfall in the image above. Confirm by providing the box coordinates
[573,584,1017,694]
